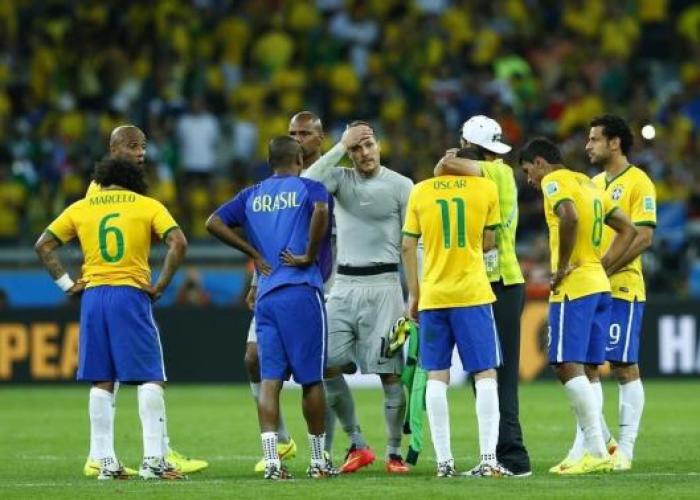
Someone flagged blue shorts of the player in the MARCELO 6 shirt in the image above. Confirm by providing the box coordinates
[77,286,167,382]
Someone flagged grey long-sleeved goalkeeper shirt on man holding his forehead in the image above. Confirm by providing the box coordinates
[302,144,413,266]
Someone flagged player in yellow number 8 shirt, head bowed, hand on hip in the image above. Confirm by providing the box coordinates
[520,138,636,474]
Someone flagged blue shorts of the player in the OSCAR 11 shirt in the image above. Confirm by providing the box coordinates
[419,304,503,373]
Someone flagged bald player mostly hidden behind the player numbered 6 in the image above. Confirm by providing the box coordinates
[83,124,209,477]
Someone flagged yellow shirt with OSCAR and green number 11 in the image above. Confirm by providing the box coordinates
[403,175,501,311]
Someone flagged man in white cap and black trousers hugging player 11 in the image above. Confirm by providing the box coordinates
[435,115,532,477]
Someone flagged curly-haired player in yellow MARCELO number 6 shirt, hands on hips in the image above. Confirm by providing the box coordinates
[35,158,187,479]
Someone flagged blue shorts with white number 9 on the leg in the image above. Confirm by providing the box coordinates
[605,298,644,363]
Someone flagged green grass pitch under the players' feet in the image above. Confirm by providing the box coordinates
[0,381,700,500]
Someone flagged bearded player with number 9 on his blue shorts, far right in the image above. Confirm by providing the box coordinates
[586,115,656,470]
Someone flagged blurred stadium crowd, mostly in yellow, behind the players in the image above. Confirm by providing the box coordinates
[0,0,700,292]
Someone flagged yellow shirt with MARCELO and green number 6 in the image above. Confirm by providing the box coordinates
[46,189,178,288]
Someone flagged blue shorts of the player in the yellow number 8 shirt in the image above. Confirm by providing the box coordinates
[549,292,611,365]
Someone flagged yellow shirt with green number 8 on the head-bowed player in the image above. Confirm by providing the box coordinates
[542,168,615,302]
